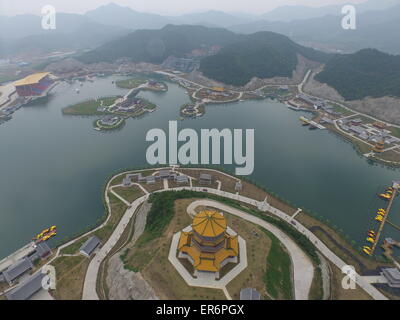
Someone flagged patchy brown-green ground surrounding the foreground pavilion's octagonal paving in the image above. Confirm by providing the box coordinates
[121,195,293,299]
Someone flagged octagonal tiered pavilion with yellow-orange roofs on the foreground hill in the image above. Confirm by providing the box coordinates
[178,210,239,279]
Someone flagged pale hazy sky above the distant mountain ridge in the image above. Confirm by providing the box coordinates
[0,0,365,15]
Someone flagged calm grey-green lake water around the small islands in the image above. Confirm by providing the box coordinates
[0,77,400,258]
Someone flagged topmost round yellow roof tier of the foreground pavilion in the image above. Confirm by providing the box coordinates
[192,210,227,237]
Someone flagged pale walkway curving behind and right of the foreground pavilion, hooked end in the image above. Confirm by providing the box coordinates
[187,200,314,300]
